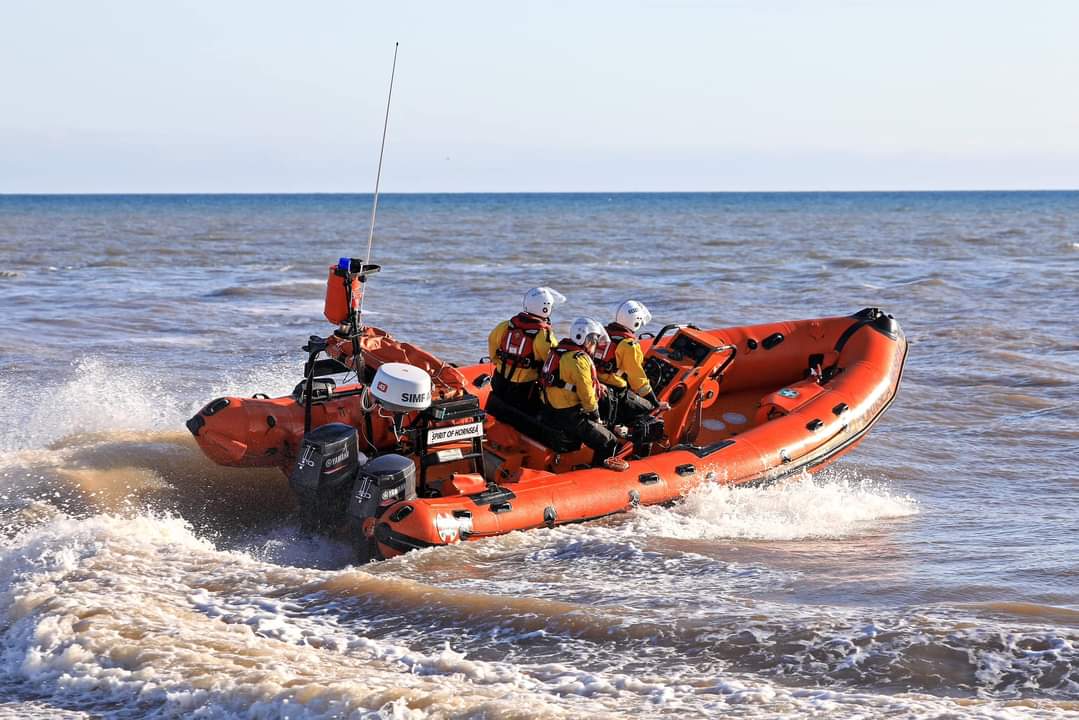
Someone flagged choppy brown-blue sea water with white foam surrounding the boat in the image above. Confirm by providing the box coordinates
[0,192,1079,718]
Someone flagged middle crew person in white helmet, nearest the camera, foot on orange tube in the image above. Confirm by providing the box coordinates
[540,317,628,470]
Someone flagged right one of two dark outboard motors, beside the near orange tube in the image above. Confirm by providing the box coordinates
[349,454,416,562]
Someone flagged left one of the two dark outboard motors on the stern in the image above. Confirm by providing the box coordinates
[288,422,367,531]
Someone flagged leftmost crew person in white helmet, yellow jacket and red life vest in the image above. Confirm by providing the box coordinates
[487,287,565,413]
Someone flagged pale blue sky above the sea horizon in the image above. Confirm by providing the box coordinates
[0,0,1079,192]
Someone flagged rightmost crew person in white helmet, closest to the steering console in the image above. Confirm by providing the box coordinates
[596,300,670,425]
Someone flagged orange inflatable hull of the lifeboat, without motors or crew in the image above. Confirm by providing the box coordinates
[189,309,907,557]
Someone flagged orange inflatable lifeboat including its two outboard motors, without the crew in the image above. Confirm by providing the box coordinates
[188,308,906,558]
